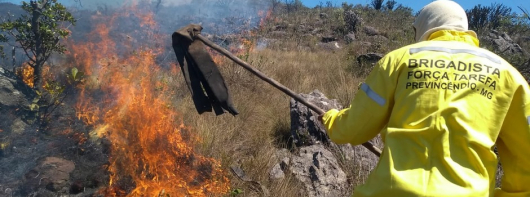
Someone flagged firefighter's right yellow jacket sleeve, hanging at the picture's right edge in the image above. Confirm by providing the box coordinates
[495,81,530,197]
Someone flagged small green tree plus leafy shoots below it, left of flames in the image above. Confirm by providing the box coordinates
[0,0,78,130]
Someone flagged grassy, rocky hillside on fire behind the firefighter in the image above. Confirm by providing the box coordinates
[0,1,530,197]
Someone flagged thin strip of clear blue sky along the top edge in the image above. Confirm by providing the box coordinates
[0,0,530,13]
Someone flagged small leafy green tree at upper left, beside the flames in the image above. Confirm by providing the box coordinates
[0,0,76,89]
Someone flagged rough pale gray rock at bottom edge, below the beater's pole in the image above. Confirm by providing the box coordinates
[290,145,348,196]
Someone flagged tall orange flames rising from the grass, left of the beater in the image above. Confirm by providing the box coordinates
[68,1,229,196]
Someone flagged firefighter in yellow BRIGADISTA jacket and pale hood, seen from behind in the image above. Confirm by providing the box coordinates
[321,0,530,197]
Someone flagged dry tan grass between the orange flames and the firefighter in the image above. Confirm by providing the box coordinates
[167,5,418,197]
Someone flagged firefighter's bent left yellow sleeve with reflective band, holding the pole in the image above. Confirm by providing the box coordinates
[322,54,398,145]
